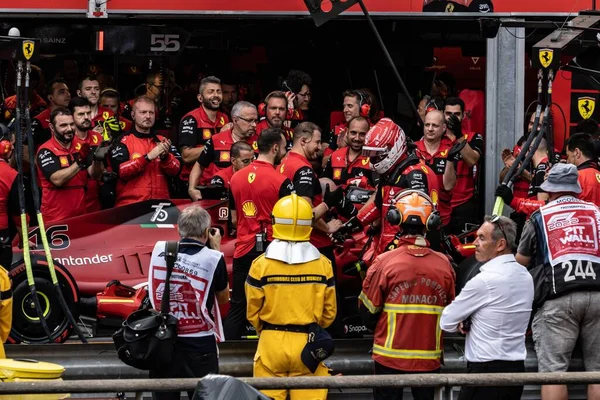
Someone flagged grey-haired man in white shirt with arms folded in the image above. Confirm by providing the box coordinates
[440,216,533,400]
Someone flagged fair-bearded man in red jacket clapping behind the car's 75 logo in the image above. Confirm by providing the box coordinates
[111,96,181,206]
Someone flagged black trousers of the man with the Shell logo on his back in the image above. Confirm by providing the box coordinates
[223,245,266,340]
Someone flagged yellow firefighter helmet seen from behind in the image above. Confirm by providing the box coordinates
[271,194,313,242]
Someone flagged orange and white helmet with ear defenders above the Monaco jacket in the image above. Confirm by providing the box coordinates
[386,190,442,231]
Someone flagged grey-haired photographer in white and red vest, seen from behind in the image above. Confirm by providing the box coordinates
[148,205,229,400]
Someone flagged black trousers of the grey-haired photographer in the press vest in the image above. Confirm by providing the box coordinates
[150,347,219,400]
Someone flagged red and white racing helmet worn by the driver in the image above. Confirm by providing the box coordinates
[363,118,406,174]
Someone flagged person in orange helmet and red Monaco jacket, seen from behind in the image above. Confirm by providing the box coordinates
[359,190,455,400]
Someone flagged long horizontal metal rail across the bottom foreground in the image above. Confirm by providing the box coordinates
[0,372,600,399]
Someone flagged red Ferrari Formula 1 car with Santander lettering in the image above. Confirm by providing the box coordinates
[9,193,478,343]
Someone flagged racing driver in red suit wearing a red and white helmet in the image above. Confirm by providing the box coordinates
[342,118,439,263]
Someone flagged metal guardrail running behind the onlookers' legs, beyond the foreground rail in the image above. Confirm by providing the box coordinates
[6,335,583,380]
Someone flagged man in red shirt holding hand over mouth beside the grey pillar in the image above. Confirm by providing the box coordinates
[444,97,484,235]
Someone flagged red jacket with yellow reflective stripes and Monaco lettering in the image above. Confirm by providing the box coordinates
[359,242,456,372]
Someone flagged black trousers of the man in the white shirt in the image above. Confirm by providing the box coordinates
[458,361,525,400]
